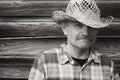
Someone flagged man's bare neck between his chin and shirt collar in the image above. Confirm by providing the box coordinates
[66,44,89,59]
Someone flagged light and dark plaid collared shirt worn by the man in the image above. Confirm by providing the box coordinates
[29,44,120,80]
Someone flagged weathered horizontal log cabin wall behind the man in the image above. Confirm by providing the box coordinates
[0,0,120,80]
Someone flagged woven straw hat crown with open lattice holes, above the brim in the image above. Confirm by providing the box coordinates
[65,0,100,21]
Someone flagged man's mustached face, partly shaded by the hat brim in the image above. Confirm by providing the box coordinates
[63,22,98,48]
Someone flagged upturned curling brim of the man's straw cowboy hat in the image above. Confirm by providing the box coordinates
[52,11,113,28]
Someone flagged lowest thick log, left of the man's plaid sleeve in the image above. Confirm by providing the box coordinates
[0,58,33,80]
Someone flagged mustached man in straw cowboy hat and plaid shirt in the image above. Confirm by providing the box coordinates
[29,0,120,80]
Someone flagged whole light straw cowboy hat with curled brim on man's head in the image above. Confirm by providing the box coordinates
[52,0,113,28]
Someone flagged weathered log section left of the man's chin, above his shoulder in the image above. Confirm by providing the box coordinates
[0,39,65,58]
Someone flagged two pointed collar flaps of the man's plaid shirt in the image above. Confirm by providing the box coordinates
[59,45,100,64]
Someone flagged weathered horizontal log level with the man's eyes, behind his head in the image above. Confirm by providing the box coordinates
[0,17,120,38]
